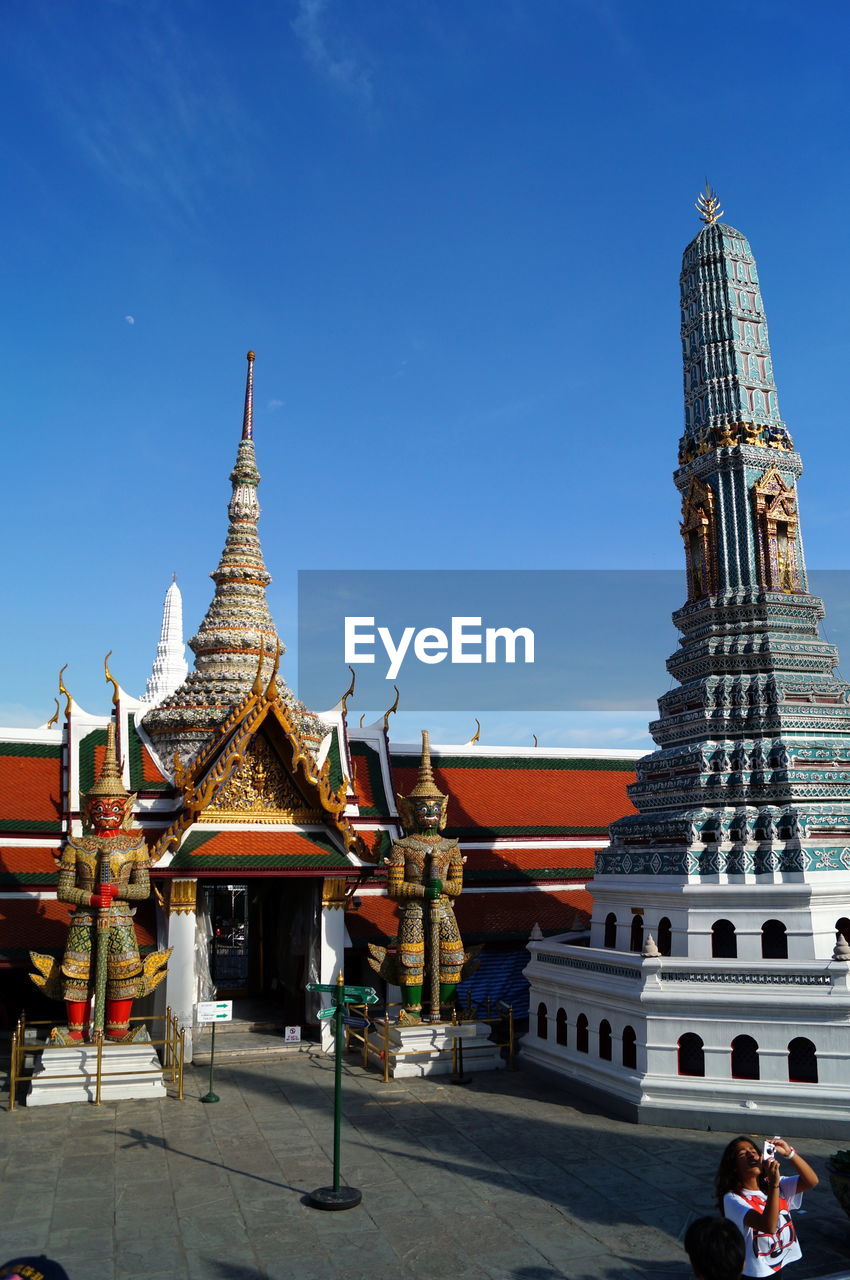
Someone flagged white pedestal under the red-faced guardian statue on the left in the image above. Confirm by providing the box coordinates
[26,1042,165,1107]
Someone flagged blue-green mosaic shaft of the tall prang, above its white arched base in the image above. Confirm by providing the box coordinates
[597,191,850,956]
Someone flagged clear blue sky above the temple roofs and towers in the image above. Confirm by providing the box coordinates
[0,0,850,745]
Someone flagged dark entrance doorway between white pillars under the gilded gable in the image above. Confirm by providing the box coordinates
[202,876,321,1036]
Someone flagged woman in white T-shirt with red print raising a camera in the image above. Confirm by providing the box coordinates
[714,1138,818,1276]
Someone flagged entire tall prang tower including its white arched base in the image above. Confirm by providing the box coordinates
[525,187,850,1134]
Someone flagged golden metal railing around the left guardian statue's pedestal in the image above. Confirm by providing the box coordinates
[9,1006,186,1111]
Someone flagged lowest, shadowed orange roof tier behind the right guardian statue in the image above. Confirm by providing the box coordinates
[346,890,593,942]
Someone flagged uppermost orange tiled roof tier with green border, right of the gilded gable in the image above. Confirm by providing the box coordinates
[392,754,635,840]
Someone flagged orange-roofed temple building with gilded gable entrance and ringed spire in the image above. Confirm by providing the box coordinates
[0,353,640,1052]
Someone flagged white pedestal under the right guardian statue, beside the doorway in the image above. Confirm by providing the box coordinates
[369,1019,504,1079]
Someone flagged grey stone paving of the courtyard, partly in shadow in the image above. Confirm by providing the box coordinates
[0,1047,850,1280]
